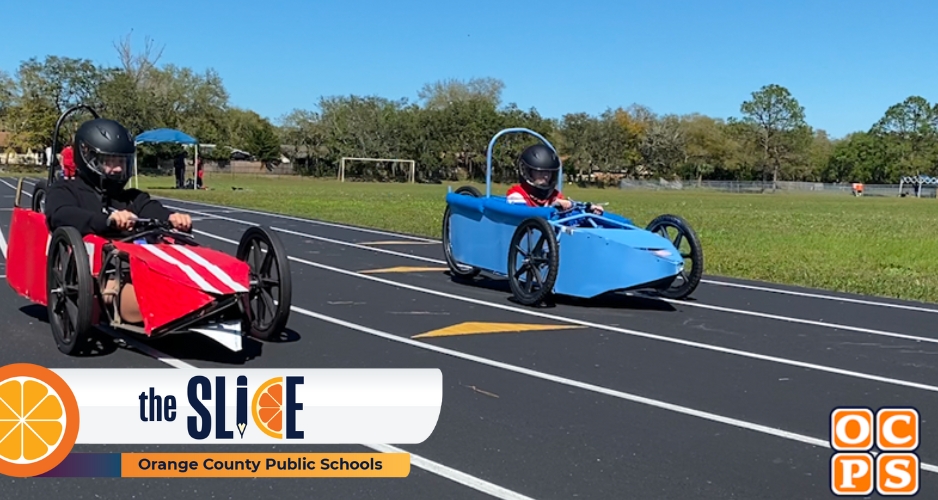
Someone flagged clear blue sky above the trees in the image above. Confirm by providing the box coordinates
[0,0,938,137]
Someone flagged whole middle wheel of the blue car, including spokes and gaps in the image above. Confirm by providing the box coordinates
[508,217,560,306]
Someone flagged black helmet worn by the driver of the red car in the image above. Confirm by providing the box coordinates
[73,118,136,188]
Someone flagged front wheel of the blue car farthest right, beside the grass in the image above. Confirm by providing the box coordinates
[646,214,704,299]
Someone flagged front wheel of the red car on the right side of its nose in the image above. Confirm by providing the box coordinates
[237,226,293,340]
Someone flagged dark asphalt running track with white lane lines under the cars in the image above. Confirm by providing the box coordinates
[0,178,938,500]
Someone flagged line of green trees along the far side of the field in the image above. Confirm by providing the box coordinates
[0,34,938,183]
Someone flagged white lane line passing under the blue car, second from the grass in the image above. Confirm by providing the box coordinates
[172,207,938,344]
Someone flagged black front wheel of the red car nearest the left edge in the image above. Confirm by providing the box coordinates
[46,227,94,355]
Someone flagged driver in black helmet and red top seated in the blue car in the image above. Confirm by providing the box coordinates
[506,144,603,214]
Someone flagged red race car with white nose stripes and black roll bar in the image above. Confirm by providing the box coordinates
[7,106,292,354]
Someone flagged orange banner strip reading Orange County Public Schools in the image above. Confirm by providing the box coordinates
[121,453,410,477]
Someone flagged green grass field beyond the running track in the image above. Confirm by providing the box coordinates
[140,175,938,302]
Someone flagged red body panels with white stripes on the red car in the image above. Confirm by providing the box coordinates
[7,207,250,335]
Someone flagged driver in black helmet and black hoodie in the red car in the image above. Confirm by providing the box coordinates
[46,118,192,323]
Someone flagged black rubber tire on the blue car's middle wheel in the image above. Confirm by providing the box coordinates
[508,217,560,306]
